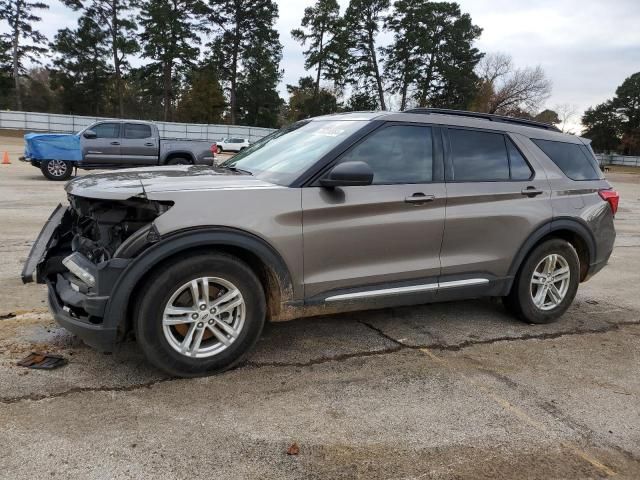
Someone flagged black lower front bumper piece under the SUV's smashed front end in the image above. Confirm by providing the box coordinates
[47,282,118,351]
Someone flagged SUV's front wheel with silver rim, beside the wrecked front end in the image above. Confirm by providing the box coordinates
[134,253,266,377]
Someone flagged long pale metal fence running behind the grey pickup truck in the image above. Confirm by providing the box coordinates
[0,110,273,142]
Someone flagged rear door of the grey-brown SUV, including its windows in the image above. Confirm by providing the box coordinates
[439,127,552,288]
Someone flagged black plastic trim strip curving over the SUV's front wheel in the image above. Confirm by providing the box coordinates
[103,227,293,333]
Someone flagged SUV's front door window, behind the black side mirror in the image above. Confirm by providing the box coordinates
[340,125,433,185]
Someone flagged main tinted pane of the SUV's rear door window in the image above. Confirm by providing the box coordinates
[449,128,509,182]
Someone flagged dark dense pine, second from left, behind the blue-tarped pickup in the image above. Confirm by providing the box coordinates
[51,14,112,115]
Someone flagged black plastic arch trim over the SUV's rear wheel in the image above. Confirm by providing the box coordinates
[508,218,596,288]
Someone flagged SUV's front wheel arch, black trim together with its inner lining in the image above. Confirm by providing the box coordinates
[104,227,293,338]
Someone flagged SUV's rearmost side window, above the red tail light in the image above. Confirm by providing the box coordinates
[531,138,603,180]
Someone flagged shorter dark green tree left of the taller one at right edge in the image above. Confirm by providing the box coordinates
[582,100,623,152]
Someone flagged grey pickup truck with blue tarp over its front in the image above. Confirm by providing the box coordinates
[20,120,216,180]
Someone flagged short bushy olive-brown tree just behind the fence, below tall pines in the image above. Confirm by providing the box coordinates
[176,64,226,123]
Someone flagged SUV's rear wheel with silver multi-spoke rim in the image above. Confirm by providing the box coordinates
[503,239,580,324]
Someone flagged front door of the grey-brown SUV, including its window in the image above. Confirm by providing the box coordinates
[302,124,446,300]
